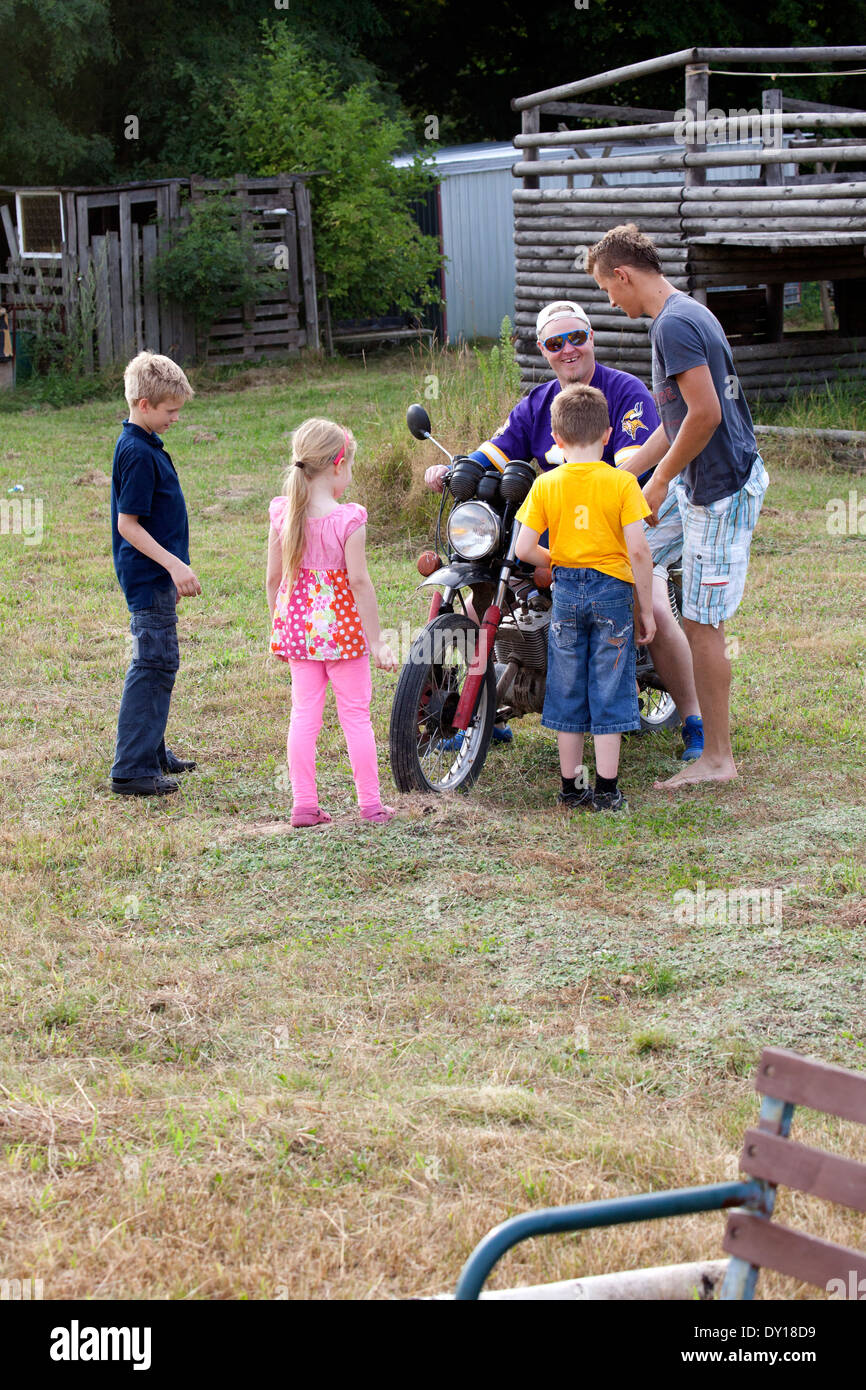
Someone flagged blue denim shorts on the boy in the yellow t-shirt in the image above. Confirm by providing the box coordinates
[541,564,641,734]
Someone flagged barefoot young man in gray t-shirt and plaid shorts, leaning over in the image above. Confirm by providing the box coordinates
[587,222,769,791]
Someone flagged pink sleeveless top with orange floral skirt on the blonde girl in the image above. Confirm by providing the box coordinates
[268,498,370,662]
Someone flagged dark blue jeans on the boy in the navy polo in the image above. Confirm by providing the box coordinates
[111,584,181,778]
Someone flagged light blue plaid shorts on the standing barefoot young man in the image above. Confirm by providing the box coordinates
[677,455,770,627]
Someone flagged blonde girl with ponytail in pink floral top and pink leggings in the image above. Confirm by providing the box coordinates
[267,420,398,826]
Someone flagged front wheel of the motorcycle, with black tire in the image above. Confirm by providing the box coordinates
[389,613,496,791]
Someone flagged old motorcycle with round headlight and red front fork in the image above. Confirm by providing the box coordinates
[389,404,681,791]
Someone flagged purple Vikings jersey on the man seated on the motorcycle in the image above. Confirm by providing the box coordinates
[470,363,659,482]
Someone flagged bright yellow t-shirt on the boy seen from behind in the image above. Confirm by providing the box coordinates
[517,460,649,584]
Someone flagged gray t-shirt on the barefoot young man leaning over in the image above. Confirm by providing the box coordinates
[649,293,758,507]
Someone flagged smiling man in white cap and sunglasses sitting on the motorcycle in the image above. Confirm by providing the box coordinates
[424,300,703,762]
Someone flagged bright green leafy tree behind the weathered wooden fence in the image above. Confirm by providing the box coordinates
[224,29,439,317]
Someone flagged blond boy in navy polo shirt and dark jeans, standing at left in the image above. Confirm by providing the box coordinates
[111,352,202,796]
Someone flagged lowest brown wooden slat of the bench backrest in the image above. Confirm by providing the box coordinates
[721,1211,866,1289]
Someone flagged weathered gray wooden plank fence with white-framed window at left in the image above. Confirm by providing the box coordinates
[0,174,320,367]
